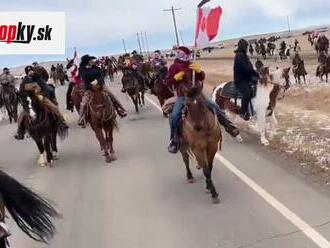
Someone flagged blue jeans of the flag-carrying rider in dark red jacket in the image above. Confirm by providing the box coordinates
[170,96,230,139]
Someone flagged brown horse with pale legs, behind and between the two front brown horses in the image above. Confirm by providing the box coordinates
[121,71,145,113]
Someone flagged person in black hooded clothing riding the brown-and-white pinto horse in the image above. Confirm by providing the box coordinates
[234,39,259,121]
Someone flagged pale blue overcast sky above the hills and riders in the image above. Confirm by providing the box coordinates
[0,0,330,67]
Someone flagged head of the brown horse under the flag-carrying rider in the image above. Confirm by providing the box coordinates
[185,88,207,132]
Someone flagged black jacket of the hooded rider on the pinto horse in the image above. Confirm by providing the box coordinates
[234,51,259,86]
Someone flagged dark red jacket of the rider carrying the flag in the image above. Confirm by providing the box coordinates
[166,59,205,96]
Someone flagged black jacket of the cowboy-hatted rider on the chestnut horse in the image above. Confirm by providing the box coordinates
[79,65,104,90]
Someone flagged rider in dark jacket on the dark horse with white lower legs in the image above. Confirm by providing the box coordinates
[15,65,68,140]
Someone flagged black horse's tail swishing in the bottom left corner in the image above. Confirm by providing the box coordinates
[0,170,60,243]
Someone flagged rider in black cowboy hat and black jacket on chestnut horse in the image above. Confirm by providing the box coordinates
[79,54,127,126]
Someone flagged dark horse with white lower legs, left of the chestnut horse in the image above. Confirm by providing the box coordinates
[20,87,68,167]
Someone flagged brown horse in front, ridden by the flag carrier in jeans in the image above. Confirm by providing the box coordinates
[180,88,222,203]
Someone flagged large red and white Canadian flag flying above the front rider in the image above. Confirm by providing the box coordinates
[195,7,222,47]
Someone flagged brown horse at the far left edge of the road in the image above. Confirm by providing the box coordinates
[0,84,18,123]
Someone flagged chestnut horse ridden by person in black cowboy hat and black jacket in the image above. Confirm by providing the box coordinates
[86,86,118,163]
